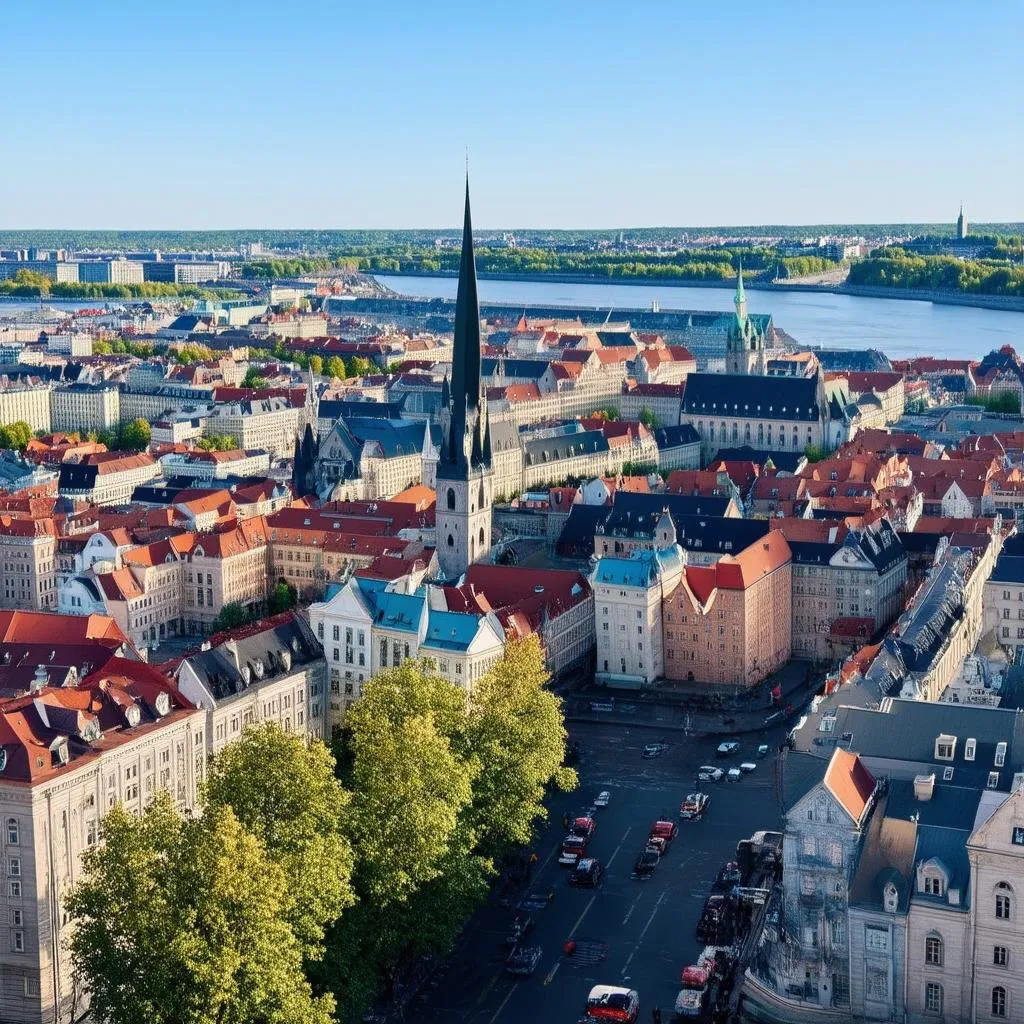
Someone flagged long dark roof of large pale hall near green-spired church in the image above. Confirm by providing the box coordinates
[683,374,820,423]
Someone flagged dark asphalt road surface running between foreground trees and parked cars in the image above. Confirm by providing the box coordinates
[406,725,784,1024]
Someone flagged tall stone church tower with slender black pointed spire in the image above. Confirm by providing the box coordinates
[436,178,494,579]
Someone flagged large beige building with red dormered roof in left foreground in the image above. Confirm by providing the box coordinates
[0,612,206,1024]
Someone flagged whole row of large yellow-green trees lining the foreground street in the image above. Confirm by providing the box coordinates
[67,639,575,1024]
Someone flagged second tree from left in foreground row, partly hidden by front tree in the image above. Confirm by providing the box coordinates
[204,724,353,957]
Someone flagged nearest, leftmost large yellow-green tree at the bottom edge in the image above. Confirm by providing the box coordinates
[66,791,334,1024]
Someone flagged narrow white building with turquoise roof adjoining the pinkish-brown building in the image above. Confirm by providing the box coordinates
[591,544,684,689]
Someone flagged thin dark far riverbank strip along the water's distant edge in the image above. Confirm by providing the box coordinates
[373,270,1024,312]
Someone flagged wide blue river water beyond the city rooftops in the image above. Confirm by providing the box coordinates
[380,274,1024,359]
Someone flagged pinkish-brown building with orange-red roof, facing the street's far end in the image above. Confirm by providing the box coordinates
[664,530,793,688]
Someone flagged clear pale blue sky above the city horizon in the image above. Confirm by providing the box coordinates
[0,0,1024,228]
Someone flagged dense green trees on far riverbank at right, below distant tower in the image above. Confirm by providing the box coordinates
[848,247,1024,296]
